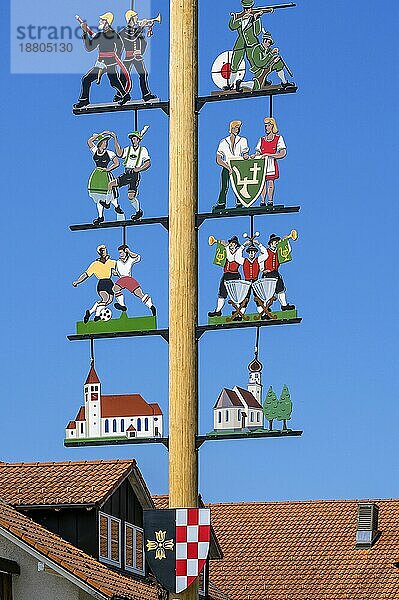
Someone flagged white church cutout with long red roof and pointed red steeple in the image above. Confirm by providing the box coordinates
[65,361,163,441]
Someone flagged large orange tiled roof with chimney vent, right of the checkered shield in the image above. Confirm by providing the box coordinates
[209,497,399,600]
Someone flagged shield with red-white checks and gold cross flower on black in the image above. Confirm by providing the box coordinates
[144,508,211,593]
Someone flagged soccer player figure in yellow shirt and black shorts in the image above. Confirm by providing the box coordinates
[72,244,116,323]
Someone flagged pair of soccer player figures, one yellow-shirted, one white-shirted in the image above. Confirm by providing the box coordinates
[72,244,157,323]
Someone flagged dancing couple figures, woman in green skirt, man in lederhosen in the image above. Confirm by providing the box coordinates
[87,125,151,225]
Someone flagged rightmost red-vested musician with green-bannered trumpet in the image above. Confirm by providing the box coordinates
[262,229,298,311]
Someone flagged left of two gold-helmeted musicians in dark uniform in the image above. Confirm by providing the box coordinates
[74,13,130,108]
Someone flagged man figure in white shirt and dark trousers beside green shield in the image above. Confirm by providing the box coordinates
[213,121,249,212]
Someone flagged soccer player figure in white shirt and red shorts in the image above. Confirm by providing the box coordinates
[113,244,157,317]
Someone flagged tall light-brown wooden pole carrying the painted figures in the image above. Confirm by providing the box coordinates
[169,0,198,600]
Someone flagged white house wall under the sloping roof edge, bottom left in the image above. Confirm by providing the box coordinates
[0,535,93,600]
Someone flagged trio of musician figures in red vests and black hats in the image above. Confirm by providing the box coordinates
[208,233,295,320]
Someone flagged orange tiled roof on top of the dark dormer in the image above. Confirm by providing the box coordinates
[0,460,145,506]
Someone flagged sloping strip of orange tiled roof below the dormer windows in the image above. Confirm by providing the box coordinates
[0,500,158,600]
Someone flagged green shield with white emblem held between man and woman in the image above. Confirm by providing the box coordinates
[230,157,266,208]
